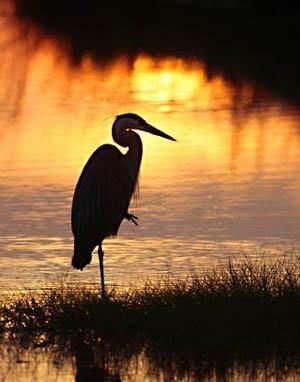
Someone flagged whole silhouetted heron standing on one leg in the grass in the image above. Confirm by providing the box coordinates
[72,113,176,298]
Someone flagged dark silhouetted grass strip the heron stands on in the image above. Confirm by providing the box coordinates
[0,259,300,350]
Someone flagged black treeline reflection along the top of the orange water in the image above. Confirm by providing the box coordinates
[12,0,300,103]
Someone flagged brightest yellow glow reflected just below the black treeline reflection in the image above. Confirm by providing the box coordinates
[131,55,229,112]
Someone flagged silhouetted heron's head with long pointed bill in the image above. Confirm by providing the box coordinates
[113,113,176,142]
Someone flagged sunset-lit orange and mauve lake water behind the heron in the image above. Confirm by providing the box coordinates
[0,2,300,290]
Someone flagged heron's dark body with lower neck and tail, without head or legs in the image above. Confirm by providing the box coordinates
[72,137,143,269]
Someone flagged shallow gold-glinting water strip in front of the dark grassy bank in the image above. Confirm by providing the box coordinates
[0,345,300,382]
